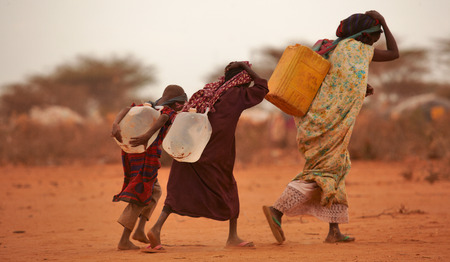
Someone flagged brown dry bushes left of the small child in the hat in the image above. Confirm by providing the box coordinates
[0,115,120,165]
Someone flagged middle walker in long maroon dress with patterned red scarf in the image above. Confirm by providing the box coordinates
[142,62,269,252]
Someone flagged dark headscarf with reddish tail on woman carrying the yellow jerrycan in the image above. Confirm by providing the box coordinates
[312,14,382,58]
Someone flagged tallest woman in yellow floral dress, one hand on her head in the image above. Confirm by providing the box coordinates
[263,11,399,244]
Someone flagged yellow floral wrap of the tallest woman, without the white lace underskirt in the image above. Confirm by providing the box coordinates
[294,39,373,206]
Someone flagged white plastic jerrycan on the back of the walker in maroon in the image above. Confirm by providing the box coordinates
[162,109,212,163]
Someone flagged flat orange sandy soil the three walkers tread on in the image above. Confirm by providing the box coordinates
[0,162,450,261]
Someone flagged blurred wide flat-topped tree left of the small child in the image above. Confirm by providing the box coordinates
[0,56,154,119]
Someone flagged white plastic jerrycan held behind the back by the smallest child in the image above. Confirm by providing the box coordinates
[114,104,160,154]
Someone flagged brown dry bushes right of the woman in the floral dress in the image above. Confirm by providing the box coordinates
[349,111,450,160]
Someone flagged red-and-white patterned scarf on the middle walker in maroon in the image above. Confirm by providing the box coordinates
[182,61,252,113]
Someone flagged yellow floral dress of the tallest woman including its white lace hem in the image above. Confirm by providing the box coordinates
[273,39,373,224]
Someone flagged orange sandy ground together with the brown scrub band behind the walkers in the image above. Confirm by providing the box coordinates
[0,93,450,261]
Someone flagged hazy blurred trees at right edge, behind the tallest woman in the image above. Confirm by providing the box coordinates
[368,39,450,109]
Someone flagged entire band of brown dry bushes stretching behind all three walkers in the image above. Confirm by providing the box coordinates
[0,111,450,169]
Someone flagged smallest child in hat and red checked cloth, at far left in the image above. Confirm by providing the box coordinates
[112,85,187,250]
